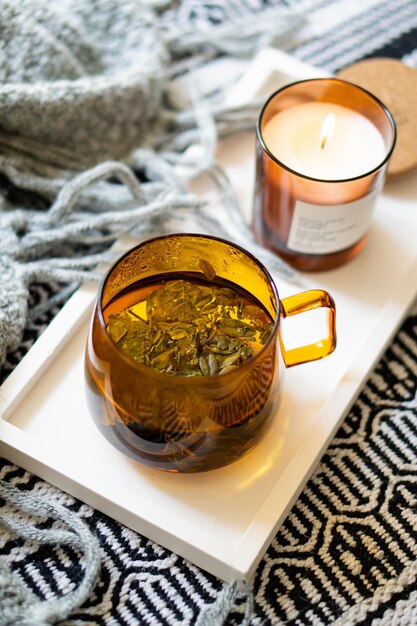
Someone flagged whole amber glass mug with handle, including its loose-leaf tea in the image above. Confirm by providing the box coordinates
[85,234,336,472]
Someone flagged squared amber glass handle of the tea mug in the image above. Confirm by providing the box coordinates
[280,289,336,367]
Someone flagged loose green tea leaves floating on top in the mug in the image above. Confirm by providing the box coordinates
[107,274,273,376]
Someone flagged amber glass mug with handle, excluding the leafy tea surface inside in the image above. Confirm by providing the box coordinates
[85,234,336,472]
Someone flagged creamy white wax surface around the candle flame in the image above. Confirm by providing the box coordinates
[262,102,386,180]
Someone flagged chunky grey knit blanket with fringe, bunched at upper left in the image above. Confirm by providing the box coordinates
[0,0,302,366]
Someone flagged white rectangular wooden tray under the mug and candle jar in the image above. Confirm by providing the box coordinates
[0,50,417,580]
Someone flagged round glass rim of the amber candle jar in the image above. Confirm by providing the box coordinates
[256,77,397,184]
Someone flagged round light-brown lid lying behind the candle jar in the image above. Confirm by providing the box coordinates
[337,58,417,174]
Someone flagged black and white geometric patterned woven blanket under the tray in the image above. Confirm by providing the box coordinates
[0,0,417,626]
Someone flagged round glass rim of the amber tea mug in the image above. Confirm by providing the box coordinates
[96,233,281,385]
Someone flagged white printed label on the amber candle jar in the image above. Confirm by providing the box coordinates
[287,190,378,254]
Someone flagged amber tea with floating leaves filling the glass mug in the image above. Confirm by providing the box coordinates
[86,262,277,472]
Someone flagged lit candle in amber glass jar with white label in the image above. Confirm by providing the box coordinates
[253,78,396,271]
